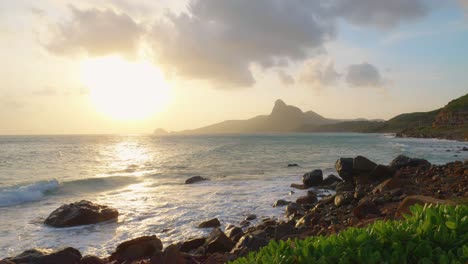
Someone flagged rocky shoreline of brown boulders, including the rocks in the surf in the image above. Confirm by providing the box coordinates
[0,156,468,264]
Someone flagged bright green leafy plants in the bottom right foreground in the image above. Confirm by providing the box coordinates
[233,205,468,264]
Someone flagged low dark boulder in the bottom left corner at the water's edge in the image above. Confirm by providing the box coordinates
[6,247,81,264]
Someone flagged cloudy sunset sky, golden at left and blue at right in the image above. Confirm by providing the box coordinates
[0,0,468,135]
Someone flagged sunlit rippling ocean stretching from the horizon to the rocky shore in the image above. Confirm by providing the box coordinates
[0,133,468,259]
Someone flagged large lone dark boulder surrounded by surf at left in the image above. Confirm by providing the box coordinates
[44,200,119,227]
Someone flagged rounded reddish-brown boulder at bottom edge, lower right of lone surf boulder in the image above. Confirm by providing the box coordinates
[110,235,163,262]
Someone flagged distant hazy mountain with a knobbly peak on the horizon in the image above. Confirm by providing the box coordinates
[180,100,339,134]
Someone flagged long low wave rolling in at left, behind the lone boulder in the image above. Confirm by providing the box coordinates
[0,176,139,207]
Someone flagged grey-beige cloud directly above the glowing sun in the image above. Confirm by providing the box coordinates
[45,6,144,57]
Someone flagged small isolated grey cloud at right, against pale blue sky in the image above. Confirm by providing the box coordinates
[346,62,384,88]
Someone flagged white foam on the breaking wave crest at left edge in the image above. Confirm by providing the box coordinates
[0,179,60,207]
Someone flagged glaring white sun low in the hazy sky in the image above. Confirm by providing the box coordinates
[81,56,170,120]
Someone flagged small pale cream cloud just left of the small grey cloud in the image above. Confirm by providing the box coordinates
[298,59,341,89]
